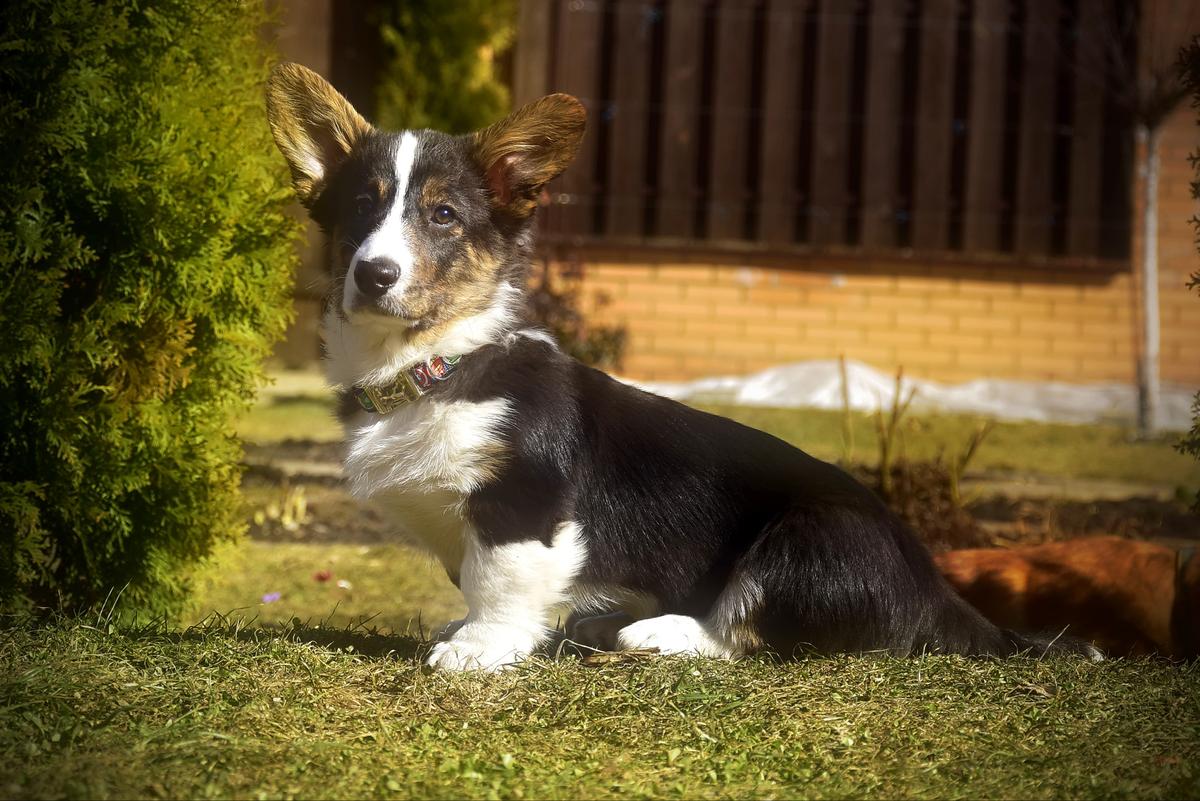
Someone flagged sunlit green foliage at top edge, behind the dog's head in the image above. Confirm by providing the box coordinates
[374,0,516,133]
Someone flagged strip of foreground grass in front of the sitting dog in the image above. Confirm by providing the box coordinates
[0,620,1200,799]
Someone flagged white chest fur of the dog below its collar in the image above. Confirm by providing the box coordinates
[346,398,509,576]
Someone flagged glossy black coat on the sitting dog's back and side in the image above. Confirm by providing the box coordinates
[412,337,1085,655]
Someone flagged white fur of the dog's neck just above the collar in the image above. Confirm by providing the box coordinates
[322,284,522,389]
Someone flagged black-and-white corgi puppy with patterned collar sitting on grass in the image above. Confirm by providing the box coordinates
[266,64,1096,670]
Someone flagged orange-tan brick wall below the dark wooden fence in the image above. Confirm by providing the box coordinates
[551,100,1200,387]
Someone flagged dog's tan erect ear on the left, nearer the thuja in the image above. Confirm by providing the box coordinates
[266,64,371,206]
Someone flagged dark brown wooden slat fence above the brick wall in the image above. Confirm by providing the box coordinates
[514,0,1133,260]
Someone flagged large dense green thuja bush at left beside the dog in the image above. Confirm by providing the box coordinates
[0,0,295,614]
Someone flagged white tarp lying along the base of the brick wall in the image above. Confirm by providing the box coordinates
[630,360,1195,430]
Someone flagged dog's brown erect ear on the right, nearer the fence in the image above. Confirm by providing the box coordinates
[474,95,588,217]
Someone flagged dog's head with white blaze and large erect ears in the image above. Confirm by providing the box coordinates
[266,64,586,347]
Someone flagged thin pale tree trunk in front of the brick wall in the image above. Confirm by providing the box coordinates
[1138,124,1159,439]
